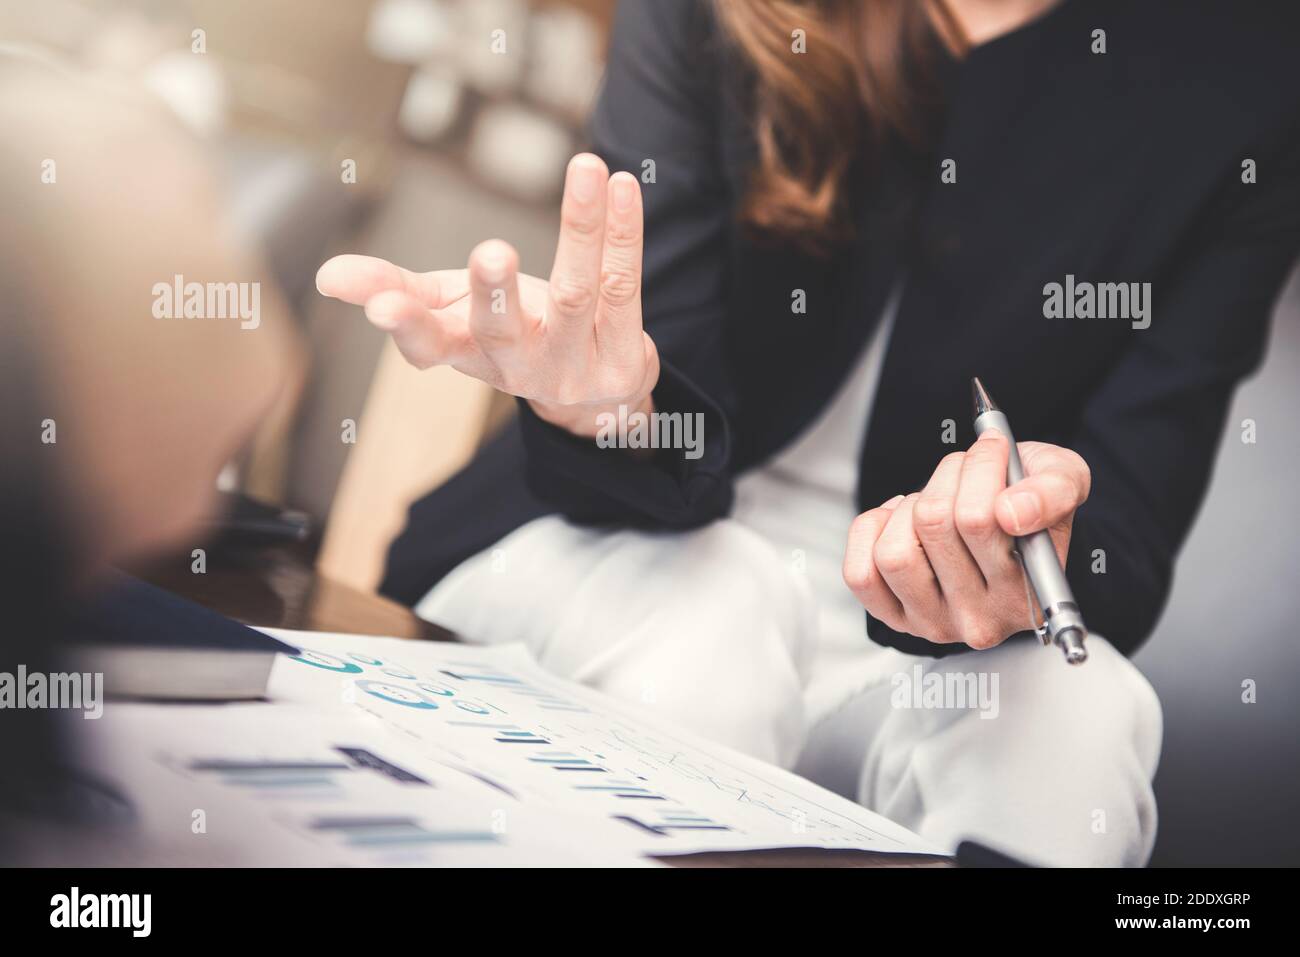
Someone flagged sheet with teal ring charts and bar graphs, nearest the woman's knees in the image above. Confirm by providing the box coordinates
[250,631,941,854]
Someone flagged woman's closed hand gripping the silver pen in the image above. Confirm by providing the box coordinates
[844,429,1092,649]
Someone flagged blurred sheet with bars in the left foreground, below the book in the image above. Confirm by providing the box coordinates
[70,702,650,867]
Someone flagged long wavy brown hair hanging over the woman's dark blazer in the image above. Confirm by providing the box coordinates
[714,0,965,250]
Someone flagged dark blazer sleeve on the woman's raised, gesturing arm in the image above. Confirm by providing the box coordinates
[519,0,732,528]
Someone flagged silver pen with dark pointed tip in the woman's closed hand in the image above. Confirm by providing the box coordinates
[971,376,1088,664]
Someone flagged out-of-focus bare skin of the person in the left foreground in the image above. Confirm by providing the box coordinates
[0,49,291,566]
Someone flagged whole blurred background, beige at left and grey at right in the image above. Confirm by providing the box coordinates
[0,0,1300,865]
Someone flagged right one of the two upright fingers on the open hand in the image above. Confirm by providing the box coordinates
[595,173,644,361]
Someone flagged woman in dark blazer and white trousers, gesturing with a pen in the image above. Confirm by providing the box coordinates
[319,0,1300,865]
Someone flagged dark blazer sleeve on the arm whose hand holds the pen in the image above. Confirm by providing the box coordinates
[1067,113,1300,654]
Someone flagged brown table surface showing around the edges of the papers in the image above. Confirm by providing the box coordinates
[129,545,952,867]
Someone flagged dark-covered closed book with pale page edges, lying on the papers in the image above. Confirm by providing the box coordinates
[65,576,298,701]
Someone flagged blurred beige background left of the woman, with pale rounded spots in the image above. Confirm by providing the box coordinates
[0,0,614,589]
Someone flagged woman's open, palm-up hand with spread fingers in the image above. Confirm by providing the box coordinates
[316,153,659,437]
